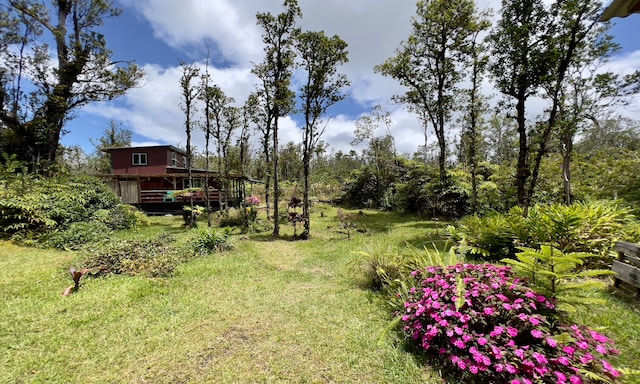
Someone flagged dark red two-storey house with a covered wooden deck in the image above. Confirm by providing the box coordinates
[100,145,255,211]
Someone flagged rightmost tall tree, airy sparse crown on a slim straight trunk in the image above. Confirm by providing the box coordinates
[544,0,640,204]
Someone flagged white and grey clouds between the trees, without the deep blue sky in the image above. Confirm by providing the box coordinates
[85,0,640,159]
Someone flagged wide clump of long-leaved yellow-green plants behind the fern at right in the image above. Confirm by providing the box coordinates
[452,201,640,268]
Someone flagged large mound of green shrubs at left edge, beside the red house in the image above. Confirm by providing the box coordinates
[0,170,146,244]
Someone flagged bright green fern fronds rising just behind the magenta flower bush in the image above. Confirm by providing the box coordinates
[502,245,615,312]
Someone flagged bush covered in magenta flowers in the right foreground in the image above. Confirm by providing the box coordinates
[400,264,620,384]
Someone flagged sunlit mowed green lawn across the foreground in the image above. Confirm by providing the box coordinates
[0,212,442,383]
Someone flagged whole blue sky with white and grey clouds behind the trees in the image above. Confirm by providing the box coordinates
[62,0,640,153]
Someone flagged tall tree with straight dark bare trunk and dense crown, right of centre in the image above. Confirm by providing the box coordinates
[488,0,550,208]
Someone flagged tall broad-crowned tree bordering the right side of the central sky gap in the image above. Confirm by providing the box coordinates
[376,0,476,183]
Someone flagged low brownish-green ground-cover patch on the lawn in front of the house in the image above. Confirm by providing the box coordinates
[78,236,190,277]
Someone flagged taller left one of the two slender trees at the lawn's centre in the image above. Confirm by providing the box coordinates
[253,0,302,236]
